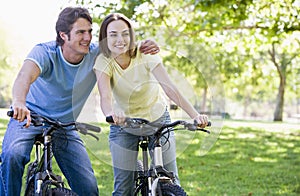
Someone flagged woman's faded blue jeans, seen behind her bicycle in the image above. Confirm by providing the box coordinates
[109,112,179,196]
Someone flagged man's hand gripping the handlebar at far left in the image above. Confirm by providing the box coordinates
[12,103,31,128]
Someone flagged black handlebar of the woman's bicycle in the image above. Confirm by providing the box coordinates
[106,116,211,134]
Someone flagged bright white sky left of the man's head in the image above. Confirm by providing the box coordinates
[0,0,68,58]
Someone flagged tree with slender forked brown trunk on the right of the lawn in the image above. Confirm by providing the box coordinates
[244,0,300,121]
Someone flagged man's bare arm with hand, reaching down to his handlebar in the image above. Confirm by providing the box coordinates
[12,60,40,127]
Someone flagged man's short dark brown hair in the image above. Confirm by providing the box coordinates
[55,7,92,46]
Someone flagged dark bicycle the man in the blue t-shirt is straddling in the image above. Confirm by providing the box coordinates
[7,110,101,196]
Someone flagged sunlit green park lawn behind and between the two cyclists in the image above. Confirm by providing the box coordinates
[0,119,300,196]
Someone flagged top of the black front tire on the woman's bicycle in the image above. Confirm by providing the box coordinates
[156,183,187,196]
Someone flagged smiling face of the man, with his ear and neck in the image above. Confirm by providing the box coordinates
[61,18,92,63]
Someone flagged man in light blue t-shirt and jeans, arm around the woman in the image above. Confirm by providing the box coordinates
[0,7,159,195]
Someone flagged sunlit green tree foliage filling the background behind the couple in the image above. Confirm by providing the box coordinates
[65,0,300,121]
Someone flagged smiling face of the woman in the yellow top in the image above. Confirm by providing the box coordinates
[107,20,130,57]
